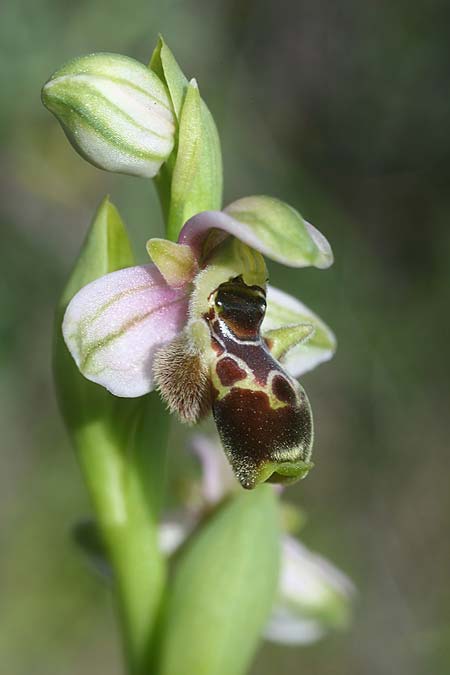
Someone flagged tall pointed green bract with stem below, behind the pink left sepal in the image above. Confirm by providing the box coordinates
[54,198,168,675]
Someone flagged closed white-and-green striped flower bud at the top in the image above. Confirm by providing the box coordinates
[42,53,175,177]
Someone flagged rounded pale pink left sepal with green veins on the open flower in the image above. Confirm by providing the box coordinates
[63,265,188,397]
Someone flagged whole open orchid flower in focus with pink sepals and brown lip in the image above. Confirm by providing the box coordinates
[63,196,335,488]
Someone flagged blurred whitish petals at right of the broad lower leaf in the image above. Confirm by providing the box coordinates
[265,536,355,644]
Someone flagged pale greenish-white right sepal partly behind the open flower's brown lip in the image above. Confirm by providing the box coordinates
[262,286,336,377]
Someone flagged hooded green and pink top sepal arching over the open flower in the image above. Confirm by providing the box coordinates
[179,196,333,268]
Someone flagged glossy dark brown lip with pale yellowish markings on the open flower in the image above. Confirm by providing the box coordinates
[205,277,313,488]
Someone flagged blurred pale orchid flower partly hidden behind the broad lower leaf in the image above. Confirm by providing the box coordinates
[159,435,355,645]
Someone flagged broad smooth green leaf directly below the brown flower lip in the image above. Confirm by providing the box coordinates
[157,485,279,675]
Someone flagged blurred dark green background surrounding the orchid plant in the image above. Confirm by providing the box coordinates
[0,0,450,675]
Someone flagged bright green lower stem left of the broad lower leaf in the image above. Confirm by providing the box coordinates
[75,402,165,675]
